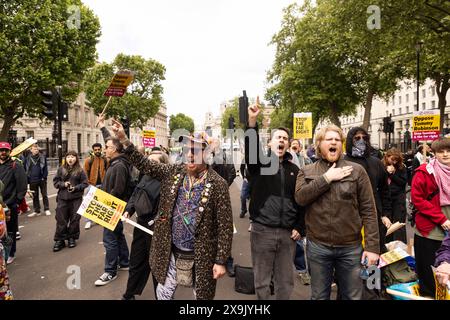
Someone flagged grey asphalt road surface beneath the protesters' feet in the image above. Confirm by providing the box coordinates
[8,172,310,300]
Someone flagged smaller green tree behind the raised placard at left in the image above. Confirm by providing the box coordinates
[83,53,165,128]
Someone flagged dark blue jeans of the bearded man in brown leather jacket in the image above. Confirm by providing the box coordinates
[306,240,363,300]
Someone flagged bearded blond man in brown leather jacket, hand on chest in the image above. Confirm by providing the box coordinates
[295,125,380,300]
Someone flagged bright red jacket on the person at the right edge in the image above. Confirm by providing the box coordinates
[411,163,447,237]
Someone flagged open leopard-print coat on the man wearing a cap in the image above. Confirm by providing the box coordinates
[125,145,233,300]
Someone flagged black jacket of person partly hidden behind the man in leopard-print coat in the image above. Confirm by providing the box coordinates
[125,175,161,220]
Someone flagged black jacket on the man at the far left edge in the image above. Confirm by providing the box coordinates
[0,158,27,207]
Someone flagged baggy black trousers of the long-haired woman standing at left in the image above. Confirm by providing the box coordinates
[54,198,83,241]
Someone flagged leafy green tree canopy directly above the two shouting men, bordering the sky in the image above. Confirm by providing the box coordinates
[266,1,360,126]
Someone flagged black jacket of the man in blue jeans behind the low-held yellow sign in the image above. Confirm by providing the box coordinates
[102,154,132,201]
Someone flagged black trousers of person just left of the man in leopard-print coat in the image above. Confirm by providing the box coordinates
[124,216,158,298]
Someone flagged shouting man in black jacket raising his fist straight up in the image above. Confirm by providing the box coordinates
[245,102,301,300]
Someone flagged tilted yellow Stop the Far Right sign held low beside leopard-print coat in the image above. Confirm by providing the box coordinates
[77,186,127,231]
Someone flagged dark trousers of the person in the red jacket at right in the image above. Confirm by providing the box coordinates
[414,235,442,297]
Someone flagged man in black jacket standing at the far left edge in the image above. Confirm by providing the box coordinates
[0,142,27,264]
